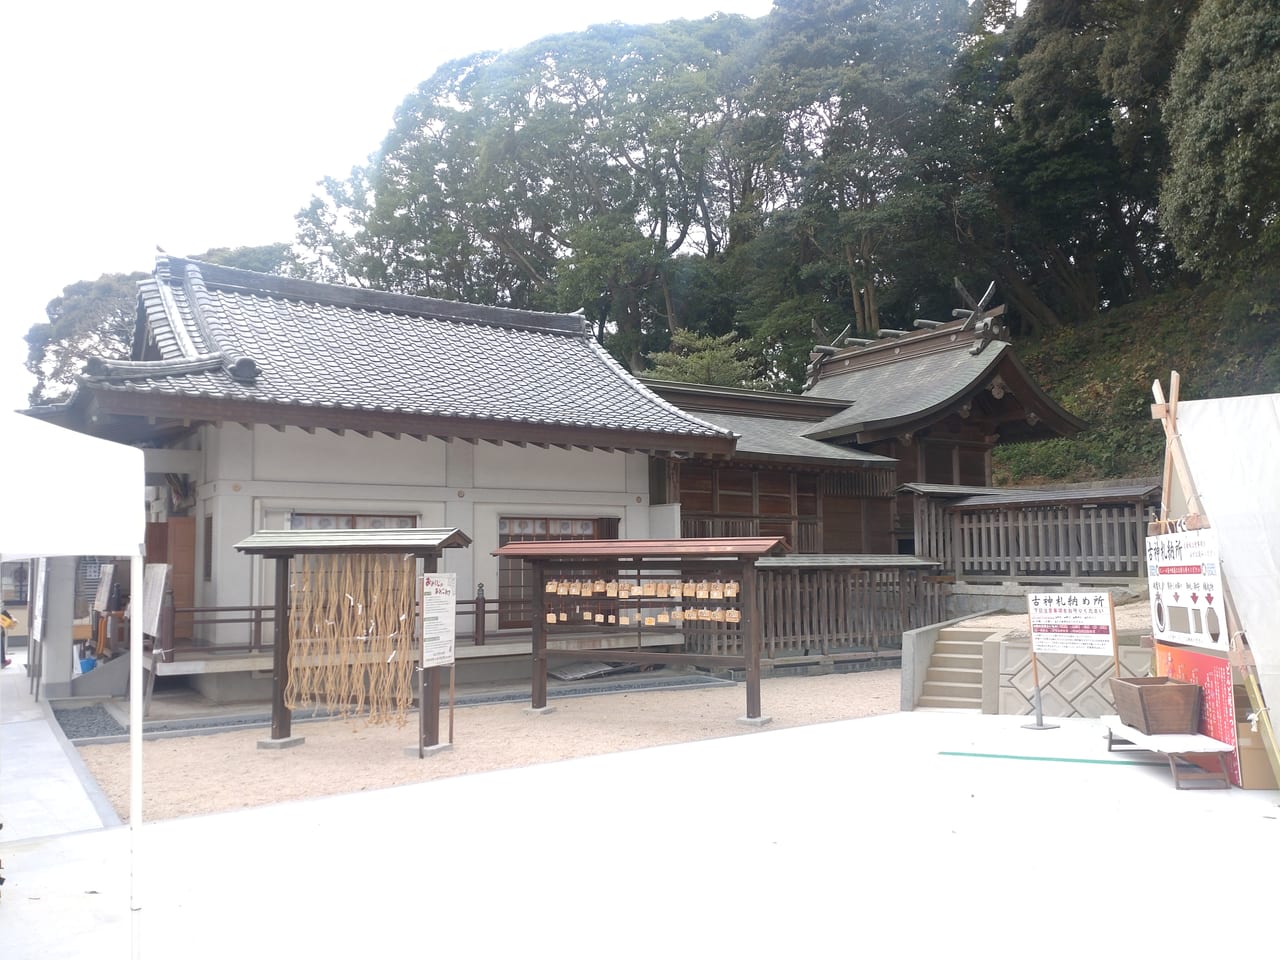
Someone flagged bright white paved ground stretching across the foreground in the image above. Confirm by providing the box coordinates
[0,650,1280,960]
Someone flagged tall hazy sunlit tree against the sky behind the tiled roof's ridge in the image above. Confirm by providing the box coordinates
[298,15,759,370]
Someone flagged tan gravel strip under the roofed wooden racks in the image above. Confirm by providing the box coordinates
[79,669,901,820]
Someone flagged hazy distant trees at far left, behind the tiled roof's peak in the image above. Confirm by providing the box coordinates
[26,243,300,404]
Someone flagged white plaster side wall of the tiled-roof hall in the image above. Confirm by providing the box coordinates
[197,424,678,643]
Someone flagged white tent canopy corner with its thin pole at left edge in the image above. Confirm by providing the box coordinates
[0,411,146,951]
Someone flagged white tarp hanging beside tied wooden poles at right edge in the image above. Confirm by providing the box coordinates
[1178,393,1280,707]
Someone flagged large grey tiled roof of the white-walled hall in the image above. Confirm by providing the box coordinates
[90,257,732,452]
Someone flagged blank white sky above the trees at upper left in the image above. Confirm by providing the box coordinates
[0,0,772,410]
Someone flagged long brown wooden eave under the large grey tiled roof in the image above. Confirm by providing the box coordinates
[86,390,735,457]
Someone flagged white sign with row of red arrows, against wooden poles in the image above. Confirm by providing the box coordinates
[1147,530,1228,650]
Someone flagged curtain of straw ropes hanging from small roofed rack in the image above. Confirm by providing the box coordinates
[284,553,415,726]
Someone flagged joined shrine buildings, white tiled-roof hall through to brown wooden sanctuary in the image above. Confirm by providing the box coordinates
[31,256,1083,680]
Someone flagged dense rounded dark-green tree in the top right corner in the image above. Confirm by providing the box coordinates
[1160,0,1280,276]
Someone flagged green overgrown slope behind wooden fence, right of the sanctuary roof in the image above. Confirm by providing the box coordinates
[995,278,1280,485]
